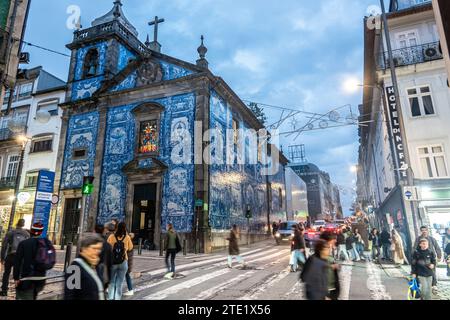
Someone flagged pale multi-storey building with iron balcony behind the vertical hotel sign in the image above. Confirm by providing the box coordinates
[357,0,450,251]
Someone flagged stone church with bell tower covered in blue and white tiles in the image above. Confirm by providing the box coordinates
[52,1,287,252]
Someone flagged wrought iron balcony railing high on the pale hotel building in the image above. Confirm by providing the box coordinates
[378,42,443,70]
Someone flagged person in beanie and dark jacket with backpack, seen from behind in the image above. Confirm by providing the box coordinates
[14,223,56,300]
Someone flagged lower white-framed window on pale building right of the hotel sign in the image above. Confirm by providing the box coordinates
[419,145,448,178]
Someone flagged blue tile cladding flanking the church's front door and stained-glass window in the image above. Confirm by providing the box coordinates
[97,93,195,232]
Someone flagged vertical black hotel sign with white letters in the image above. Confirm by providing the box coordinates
[386,87,408,181]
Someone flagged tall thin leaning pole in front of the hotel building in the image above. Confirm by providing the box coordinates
[380,0,418,240]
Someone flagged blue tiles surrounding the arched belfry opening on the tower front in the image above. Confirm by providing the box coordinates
[72,42,107,101]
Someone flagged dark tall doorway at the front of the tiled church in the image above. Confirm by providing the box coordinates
[131,184,157,249]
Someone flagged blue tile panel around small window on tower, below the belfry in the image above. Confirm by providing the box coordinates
[61,112,99,189]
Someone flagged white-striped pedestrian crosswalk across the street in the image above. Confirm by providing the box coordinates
[127,245,422,300]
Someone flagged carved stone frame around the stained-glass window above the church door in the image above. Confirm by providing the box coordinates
[133,102,165,159]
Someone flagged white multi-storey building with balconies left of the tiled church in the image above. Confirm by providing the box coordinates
[0,67,66,234]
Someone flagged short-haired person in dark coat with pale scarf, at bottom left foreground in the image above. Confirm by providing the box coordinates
[64,233,105,301]
